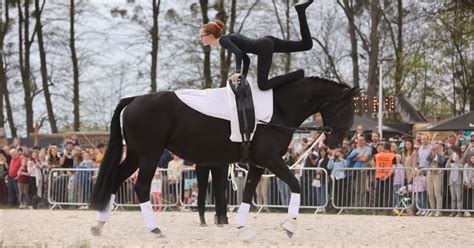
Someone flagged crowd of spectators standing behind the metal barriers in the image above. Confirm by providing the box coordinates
[0,128,474,216]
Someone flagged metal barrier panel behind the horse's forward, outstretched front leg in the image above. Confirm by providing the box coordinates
[253,167,329,213]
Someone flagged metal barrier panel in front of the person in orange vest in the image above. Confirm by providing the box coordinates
[331,167,413,213]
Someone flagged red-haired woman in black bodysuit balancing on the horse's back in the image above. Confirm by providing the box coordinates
[200,0,313,90]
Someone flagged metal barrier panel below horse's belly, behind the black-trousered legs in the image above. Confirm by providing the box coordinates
[179,167,247,208]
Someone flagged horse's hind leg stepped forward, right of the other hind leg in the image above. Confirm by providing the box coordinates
[134,153,163,237]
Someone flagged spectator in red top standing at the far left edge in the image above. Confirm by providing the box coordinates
[8,148,22,207]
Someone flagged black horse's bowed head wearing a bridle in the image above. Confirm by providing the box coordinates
[320,88,359,149]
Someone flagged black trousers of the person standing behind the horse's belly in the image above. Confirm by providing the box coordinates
[196,165,229,216]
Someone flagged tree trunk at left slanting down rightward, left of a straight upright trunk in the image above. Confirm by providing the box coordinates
[35,0,58,133]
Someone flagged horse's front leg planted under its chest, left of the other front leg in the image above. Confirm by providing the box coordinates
[235,165,264,239]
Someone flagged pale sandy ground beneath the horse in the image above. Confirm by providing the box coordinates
[0,210,474,247]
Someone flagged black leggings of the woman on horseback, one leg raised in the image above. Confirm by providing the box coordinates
[255,7,313,90]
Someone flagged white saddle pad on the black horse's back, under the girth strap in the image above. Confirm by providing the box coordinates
[175,81,273,142]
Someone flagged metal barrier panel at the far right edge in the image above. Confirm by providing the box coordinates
[413,168,474,216]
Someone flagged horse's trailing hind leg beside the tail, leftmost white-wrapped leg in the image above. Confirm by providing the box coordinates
[91,149,138,236]
